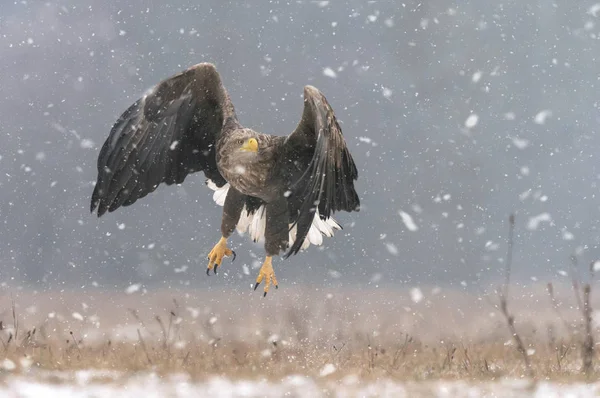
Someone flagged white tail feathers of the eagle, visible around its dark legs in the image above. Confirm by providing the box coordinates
[207,180,342,250]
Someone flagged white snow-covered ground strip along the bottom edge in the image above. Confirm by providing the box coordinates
[0,371,600,398]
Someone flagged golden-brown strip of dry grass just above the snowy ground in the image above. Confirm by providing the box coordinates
[3,332,597,380]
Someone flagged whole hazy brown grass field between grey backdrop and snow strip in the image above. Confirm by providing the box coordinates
[0,285,600,381]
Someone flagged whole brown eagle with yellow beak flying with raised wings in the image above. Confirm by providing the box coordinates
[91,63,360,296]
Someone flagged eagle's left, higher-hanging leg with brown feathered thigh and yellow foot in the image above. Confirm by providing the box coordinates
[206,187,246,275]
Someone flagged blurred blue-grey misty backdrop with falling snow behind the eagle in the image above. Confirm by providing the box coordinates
[0,0,600,289]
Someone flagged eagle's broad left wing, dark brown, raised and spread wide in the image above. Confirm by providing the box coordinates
[91,63,239,217]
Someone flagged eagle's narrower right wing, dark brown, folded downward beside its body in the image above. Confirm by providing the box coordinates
[283,86,360,257]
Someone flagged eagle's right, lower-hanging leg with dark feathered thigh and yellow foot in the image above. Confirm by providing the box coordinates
[254,195,289,297]
